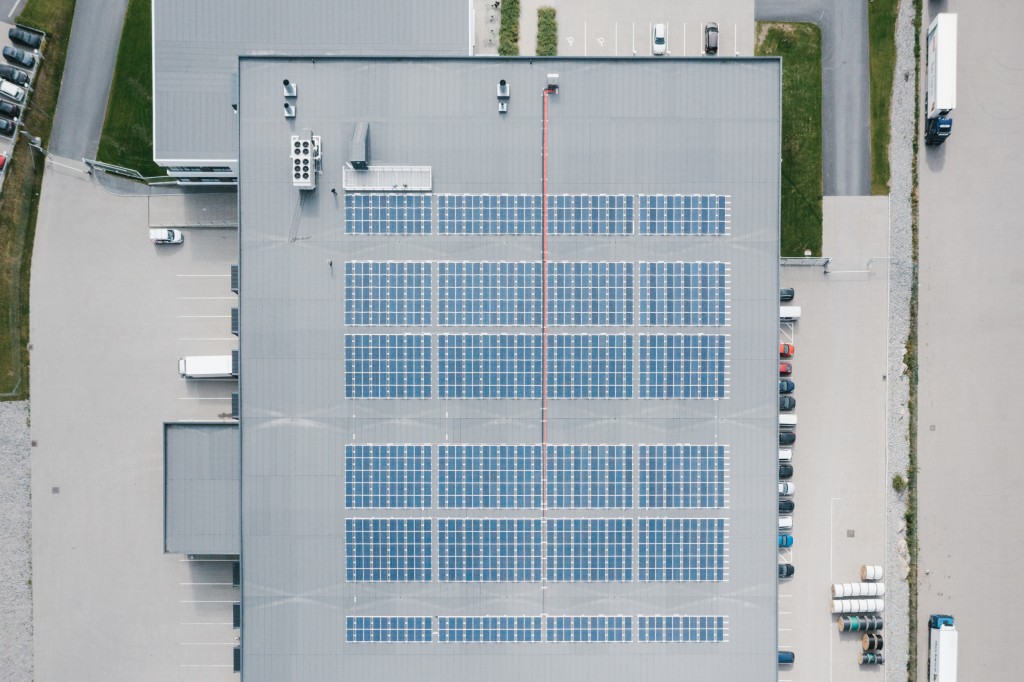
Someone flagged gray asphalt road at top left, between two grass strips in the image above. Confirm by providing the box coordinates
[49,0,128,160]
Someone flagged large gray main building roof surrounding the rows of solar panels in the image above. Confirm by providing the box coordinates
[239,58,781,682]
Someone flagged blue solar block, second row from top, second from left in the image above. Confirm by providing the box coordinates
[437,261,542,327]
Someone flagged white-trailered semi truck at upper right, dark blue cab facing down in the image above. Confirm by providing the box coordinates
[925,12,956,146]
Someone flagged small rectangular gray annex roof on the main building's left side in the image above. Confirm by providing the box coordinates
[164,422,242,555]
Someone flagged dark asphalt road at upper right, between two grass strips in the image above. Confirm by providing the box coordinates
[755,0,871,197]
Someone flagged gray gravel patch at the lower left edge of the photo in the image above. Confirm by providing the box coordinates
[0,401,32,682]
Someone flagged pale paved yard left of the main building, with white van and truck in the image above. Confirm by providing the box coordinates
[31,160,238,681]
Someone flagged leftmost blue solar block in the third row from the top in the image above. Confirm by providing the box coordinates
[345,334,430,398]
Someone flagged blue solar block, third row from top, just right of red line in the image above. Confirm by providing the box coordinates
[548,334,633,398]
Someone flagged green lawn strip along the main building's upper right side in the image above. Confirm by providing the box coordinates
[755,22,822,256]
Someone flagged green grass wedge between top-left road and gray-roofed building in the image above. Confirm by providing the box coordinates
[96,0,165,177]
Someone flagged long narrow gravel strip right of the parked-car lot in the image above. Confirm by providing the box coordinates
[885,0,920,682]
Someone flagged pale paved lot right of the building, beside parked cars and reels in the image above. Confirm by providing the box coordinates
[779,197,888,682]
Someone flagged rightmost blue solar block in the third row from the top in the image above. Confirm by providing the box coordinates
[640,334,726,398]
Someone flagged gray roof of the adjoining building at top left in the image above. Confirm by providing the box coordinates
[153,0,471,165]
